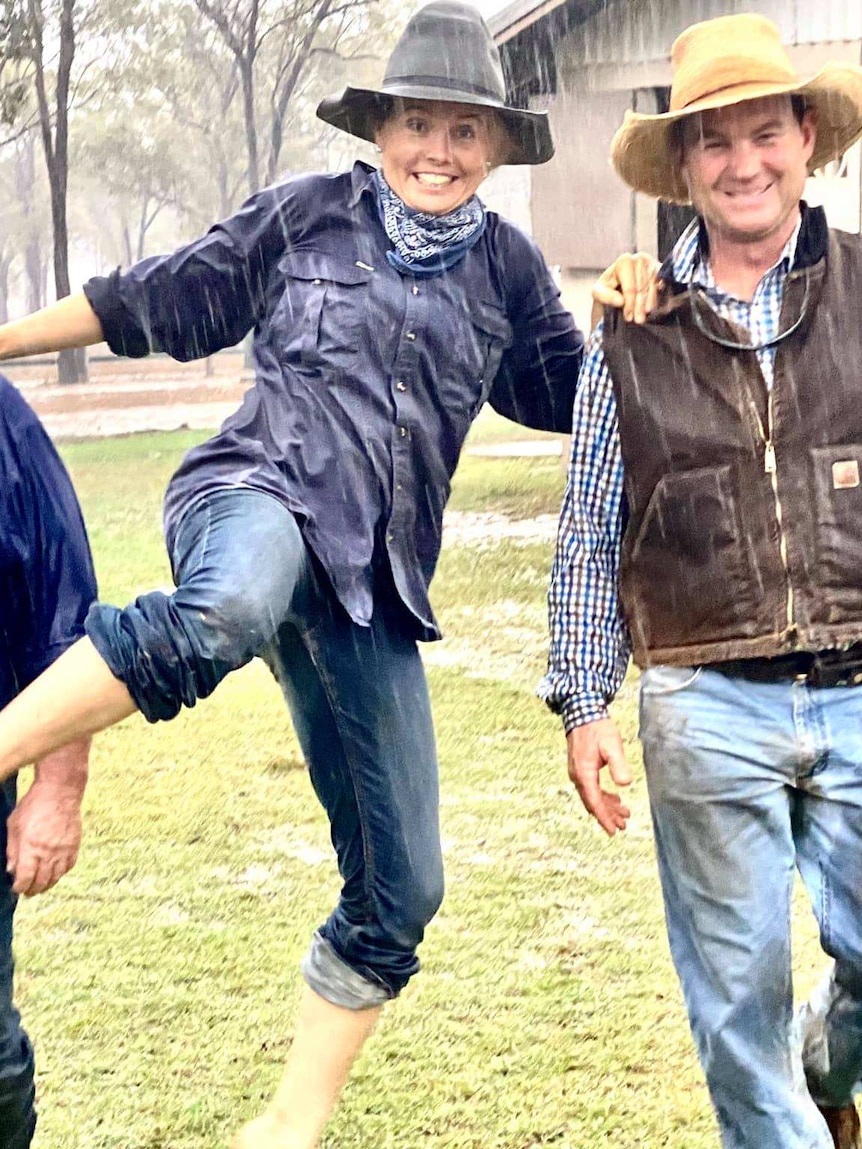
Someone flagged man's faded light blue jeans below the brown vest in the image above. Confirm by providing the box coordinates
[640,666,862,1149]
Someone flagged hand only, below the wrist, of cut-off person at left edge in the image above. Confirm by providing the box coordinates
[6,779,82,897]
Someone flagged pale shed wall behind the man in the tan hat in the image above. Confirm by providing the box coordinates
[491,0,862,268]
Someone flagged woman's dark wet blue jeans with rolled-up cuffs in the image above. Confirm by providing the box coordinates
[86,489,442,1009]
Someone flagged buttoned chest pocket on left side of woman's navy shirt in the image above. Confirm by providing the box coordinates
[272,252,372,369]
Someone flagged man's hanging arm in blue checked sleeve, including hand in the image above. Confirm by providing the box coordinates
[539,326,631,834]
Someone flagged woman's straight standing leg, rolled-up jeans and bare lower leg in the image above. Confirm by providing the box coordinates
[234,593,442,1149]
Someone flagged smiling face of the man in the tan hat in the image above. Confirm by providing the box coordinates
[682,95,816,244]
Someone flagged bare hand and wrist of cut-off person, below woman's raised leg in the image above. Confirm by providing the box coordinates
[6,739,90,897]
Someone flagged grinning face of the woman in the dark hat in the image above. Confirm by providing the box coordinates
[376,100,506,215]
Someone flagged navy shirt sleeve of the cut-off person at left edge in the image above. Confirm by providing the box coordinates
[0,376,95,707]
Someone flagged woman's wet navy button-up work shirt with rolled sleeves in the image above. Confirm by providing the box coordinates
[84,163,584,639]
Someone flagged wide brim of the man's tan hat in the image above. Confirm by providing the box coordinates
[610,64,862,203]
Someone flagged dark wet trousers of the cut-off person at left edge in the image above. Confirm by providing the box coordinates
[0,778,36,1149]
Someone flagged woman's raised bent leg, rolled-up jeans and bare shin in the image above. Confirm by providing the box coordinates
[0,491,308,779]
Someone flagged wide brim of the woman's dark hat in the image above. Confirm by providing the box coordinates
[317,84,554,164]
